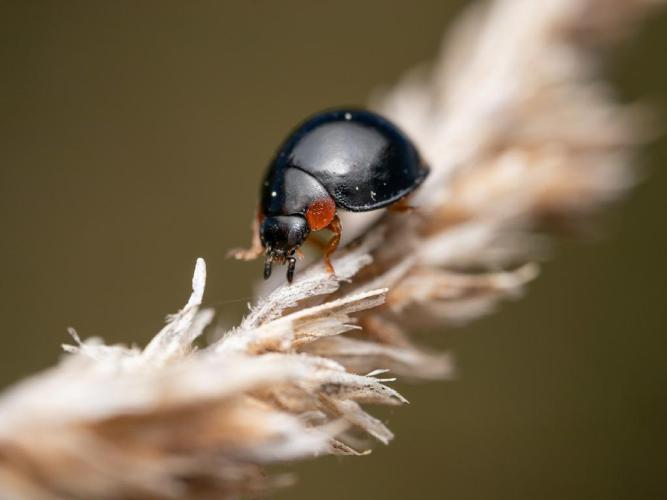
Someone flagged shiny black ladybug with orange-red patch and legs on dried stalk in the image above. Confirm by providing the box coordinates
[231,109,429,283]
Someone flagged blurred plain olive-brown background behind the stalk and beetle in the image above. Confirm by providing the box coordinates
[0,0,667,500]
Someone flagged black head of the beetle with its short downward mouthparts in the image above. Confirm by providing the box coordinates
[259,215,310,283]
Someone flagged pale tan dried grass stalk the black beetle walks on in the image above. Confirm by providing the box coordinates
[0,0,656,499]
